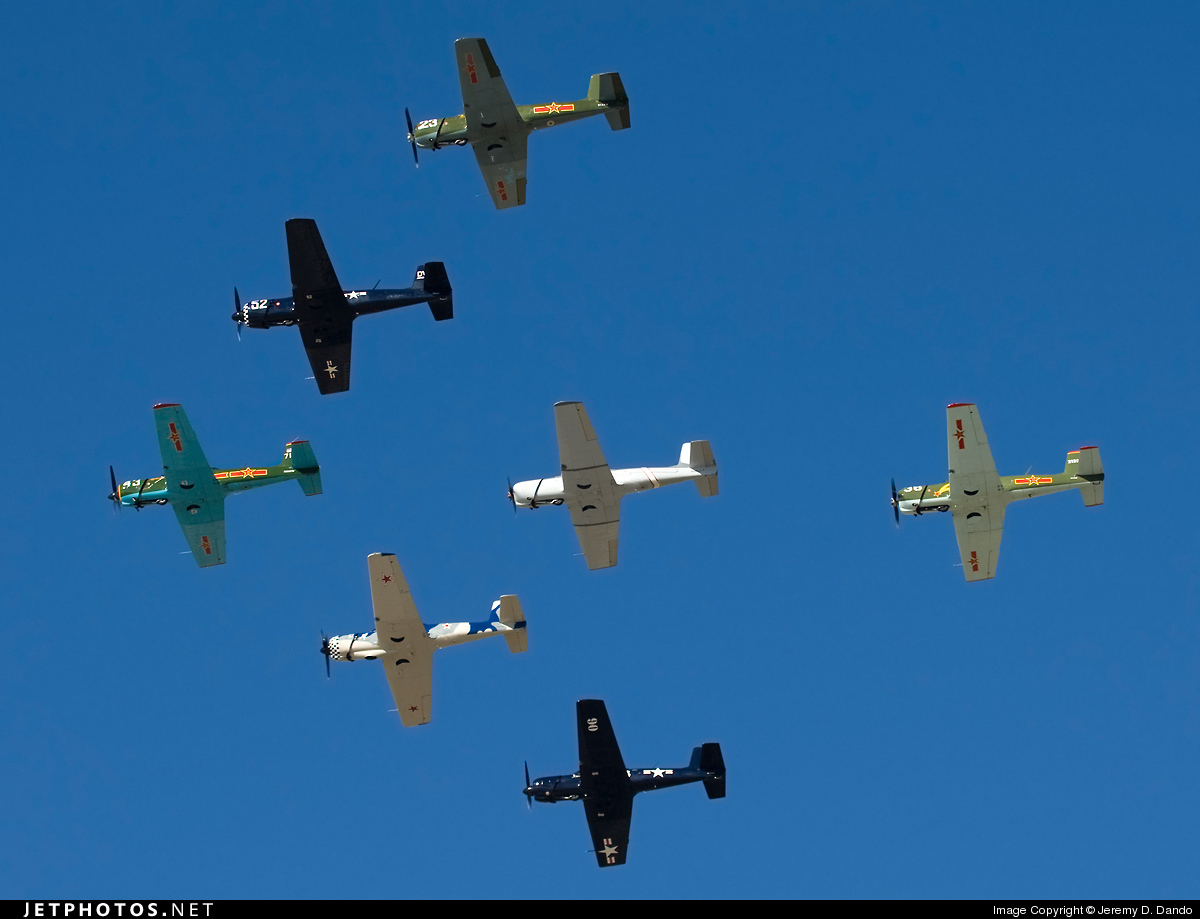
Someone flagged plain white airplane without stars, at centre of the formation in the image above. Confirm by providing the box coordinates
[509,402,716,571]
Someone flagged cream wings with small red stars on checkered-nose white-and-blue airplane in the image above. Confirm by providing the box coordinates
[367,553,433,727]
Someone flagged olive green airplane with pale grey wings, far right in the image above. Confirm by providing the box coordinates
[892,402,1104,581]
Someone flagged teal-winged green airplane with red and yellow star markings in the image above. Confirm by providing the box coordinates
[108,403,320,567]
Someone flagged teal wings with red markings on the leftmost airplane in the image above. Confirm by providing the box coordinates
[154,404,224,567]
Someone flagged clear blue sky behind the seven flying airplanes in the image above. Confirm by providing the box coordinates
[0,2,1200,897]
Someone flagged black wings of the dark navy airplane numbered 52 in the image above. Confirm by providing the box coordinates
[287,218,354,395]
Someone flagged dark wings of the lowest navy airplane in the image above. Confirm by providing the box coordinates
[575,699,634,867]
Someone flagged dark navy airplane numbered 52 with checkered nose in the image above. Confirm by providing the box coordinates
[233,218,454,395]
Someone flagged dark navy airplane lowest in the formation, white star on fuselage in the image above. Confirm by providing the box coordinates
[524,699,725,867]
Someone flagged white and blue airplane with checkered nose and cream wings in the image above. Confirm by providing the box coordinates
[320,552,529,727]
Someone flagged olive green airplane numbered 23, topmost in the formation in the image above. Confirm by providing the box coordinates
[404,38,629,210]
